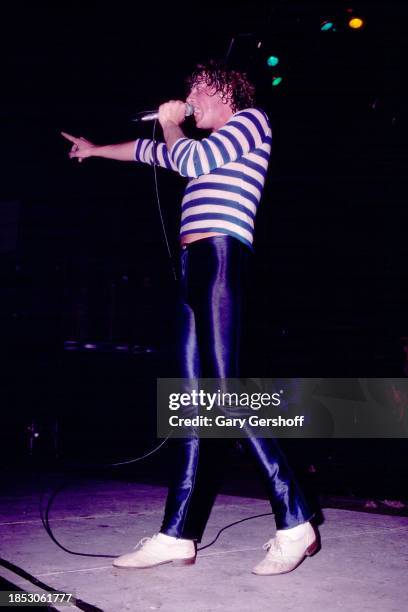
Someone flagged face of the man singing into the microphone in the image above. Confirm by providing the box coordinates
[187,81,234,131]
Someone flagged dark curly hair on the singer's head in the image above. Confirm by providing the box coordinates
[186,60,255,113]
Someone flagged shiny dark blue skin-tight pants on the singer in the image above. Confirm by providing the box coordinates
[160,235,311,542]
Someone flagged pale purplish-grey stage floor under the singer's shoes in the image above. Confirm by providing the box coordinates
[0,475,408,612]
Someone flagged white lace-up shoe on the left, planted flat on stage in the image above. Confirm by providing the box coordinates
[113,533,196,569]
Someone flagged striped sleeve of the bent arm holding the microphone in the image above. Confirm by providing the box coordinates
[169,108,272,178]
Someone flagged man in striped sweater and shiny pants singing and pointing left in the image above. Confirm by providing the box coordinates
[62,62,319,575]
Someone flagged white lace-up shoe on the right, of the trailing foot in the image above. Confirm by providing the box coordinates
[252,523,319,576]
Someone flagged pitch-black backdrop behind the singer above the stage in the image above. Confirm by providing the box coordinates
[0,0,408,496]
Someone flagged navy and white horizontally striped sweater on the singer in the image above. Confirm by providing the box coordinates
[135,108,272,248]
